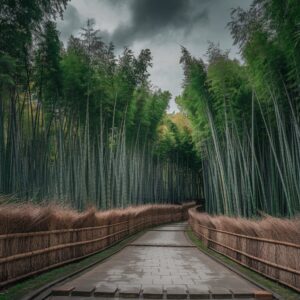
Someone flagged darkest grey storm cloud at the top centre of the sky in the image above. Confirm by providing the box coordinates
[111,0,214,45]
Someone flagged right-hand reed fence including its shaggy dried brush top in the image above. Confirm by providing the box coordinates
[189,208,300,292]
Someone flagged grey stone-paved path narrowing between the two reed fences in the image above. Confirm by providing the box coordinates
[48,223,270,300]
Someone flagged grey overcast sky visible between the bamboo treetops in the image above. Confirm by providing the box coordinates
[58,0,252,112]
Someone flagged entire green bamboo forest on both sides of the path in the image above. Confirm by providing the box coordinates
[0,0,300,217]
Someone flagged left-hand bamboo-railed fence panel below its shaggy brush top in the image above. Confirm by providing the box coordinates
[0,205,190,287]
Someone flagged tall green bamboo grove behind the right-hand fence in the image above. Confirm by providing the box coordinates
[177,0,300,217]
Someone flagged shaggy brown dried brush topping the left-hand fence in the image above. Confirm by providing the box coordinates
[0,204,195,234]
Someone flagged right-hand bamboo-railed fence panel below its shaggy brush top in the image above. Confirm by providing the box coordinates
[188,208,300,292]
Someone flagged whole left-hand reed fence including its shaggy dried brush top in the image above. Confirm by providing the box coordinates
[0,204,191,287]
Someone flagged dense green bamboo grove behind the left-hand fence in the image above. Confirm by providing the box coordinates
[0,0,201,209]
